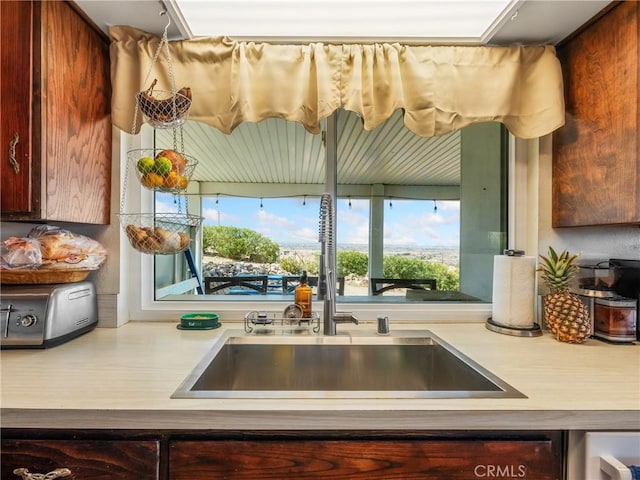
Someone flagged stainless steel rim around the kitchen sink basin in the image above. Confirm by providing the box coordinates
[171,330,527,399]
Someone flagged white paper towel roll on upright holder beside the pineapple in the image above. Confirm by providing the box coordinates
[492,255,536,328]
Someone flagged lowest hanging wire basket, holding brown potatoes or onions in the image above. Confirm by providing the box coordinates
[120,213,202,255]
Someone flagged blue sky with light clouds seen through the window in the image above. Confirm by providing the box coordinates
[156,196,460,247]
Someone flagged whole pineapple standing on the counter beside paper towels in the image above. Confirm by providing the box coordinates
[538,247,590,343]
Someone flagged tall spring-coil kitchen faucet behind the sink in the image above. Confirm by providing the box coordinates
[318,193,358,335]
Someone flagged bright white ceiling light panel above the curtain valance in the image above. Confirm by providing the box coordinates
[174,0,511,42]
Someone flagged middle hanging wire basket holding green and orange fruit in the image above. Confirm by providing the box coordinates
[127,148,198,194]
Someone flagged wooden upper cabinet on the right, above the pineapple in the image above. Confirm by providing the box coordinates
[552,2,640,227]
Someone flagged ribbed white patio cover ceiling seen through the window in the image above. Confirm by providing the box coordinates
[158,110,461,195]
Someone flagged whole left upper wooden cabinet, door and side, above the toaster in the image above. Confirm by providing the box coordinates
[0,1,111,224]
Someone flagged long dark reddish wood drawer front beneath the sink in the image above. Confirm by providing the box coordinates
[169,439,562,480]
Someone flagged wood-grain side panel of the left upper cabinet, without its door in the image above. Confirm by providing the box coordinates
[40,2,111,224]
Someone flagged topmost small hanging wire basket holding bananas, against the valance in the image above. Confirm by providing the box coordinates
[136,89,191,128]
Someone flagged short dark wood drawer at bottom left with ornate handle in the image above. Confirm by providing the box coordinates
[0,439,160,480]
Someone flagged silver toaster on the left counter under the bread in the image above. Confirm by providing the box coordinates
[0,281,98,349]
